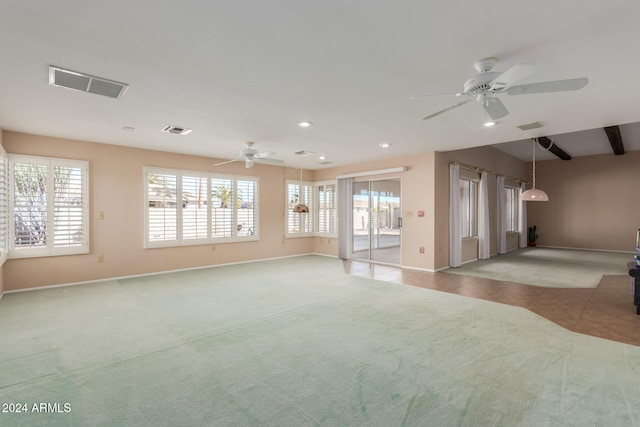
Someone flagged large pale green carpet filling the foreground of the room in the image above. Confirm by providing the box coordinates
[0,256,640,427]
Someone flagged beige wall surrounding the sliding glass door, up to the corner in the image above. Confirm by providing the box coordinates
[314,152,435,270]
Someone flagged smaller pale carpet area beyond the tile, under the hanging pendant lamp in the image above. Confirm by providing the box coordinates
[444,247,633,288]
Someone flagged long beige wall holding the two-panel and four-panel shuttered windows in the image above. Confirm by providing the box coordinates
[3,132,313,291]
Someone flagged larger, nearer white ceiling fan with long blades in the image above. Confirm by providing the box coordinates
[413,57,589,121]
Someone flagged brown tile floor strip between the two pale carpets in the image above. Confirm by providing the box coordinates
[344,260,640,346]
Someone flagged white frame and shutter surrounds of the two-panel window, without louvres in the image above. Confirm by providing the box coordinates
[7,154,90,259]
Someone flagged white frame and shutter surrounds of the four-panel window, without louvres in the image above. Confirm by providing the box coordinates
[143,166,260,249]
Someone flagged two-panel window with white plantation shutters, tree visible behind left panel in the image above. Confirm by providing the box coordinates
[9,155,89,258]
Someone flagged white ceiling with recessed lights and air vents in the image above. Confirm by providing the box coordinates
[0,0,640,169]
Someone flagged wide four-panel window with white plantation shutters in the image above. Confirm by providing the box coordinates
[145,167,258,248]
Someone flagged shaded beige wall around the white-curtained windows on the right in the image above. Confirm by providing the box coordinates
[434,147,531,269]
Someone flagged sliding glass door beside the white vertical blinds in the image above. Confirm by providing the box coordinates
[352,178,402,264]
